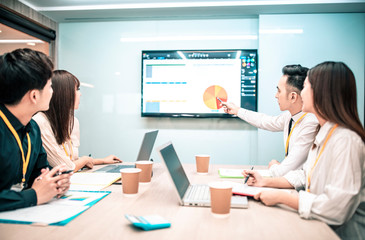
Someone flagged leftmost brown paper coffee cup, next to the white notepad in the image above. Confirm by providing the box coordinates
[120,168,142,196]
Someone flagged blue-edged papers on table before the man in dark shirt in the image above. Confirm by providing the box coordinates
[0,191,110,226]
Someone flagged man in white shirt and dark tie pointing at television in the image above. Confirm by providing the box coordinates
[222,65,318,177]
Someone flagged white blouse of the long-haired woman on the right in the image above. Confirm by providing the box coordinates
[298,134,365,225]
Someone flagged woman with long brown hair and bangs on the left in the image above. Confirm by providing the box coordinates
[33,70,121,172]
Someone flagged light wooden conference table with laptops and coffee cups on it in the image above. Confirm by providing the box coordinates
[0,163,339,240]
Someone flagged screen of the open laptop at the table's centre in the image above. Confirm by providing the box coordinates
[160,143,190,199]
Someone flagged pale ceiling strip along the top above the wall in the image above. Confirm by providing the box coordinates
[19,0,365,22]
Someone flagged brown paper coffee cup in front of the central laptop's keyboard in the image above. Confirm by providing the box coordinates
[209,181,232,218]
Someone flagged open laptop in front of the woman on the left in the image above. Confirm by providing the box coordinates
[95,130,158,173]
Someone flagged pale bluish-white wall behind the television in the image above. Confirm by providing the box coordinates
[58,14,365,164]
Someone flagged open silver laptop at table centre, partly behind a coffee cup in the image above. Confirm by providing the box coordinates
[156,142,248,208]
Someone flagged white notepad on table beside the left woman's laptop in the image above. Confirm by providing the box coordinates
[70,172,121,191]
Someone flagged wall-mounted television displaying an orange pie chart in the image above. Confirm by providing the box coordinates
[141,49,258,118]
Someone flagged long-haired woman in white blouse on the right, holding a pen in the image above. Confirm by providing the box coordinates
[244,62,365,239]
